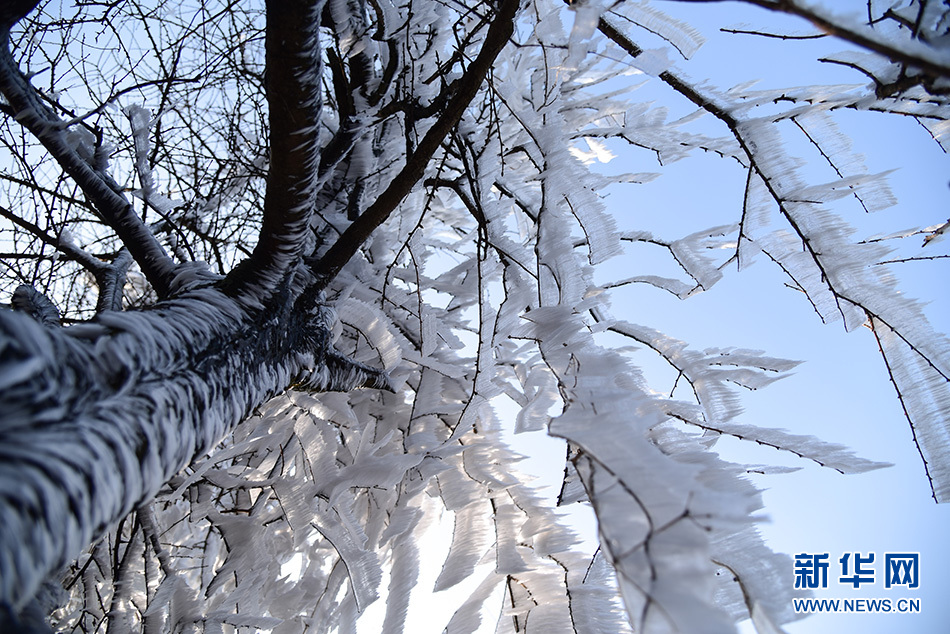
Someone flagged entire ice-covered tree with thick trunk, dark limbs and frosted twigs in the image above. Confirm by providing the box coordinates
[0,0,950,632]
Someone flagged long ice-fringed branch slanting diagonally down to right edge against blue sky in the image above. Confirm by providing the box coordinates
[600,13,950,504]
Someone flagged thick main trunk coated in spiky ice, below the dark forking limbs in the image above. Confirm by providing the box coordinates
[0,288,387,613]
